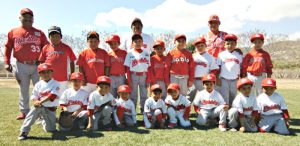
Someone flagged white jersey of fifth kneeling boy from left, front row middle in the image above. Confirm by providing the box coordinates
[144,97,167,113]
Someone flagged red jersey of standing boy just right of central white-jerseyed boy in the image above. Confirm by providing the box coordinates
[151,55,166,83]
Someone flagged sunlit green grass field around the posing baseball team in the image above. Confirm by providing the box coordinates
[0,80,300,146]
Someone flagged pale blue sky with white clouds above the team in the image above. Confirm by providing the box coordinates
[0,0,300,39]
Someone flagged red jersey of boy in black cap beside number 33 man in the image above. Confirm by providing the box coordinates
[39,43,76,81]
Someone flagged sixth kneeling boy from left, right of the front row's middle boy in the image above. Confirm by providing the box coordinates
[165,83,191,128]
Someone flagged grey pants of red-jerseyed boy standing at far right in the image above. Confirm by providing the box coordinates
[247,73,267,97]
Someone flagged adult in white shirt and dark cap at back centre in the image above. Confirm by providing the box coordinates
[123,18,154,53]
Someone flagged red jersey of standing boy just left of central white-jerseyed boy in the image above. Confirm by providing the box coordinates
[108,49,127,75]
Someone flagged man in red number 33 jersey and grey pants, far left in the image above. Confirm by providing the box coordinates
[4,8,49,120]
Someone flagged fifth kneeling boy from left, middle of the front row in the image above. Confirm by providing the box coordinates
[144,84,167,128]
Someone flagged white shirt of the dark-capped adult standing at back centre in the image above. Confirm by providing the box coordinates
[123,33,154,53]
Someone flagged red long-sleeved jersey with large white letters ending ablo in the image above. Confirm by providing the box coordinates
[165,48,195,83]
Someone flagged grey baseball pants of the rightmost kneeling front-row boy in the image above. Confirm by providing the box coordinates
[258,114,290,135]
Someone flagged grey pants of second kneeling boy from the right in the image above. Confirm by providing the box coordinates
[228,108,257,132]
